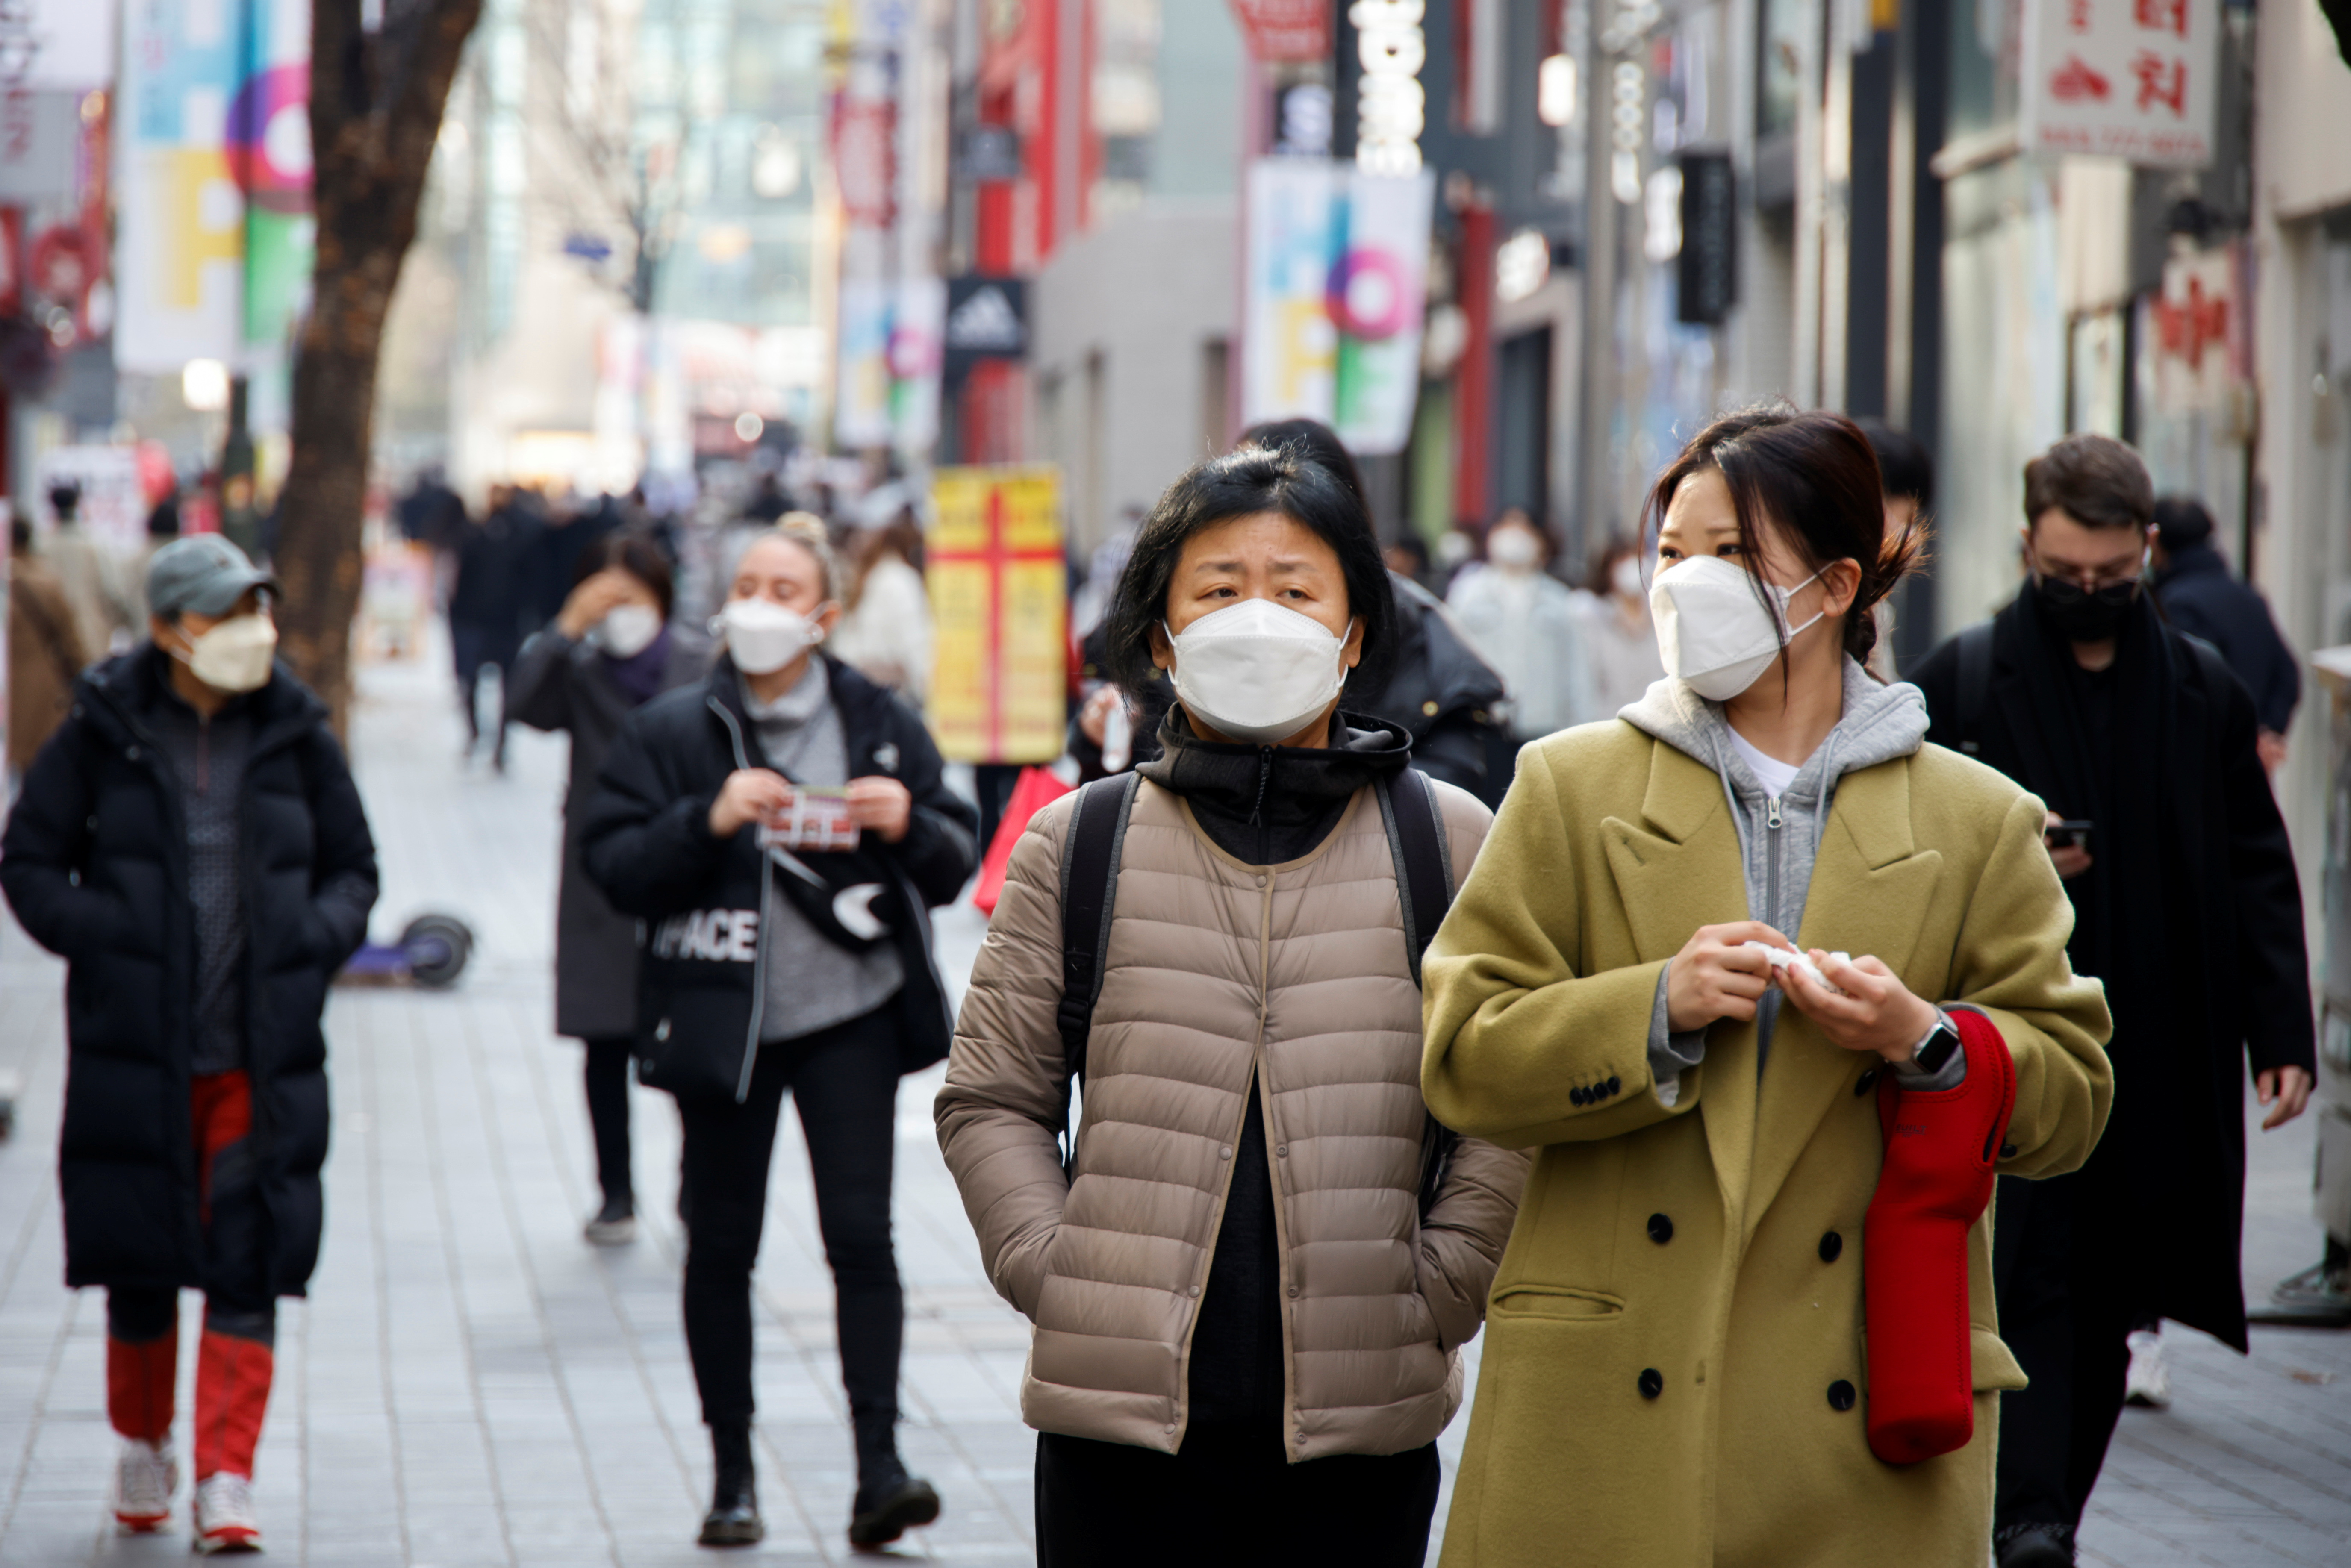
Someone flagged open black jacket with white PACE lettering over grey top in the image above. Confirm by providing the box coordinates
[578,653,978,1093]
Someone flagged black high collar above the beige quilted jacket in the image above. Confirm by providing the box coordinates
[1136,703,1413,865]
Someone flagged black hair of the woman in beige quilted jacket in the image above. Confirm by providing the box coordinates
[1103,447,1396,694]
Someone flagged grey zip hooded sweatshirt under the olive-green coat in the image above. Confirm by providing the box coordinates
[1617,658,1968,1105]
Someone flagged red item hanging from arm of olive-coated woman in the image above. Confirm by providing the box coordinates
[1862,1011,2017,1465]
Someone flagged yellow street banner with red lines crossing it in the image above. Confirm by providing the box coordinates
[926,463,1070,762]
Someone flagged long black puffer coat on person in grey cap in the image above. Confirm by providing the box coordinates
[0,644,376,1295]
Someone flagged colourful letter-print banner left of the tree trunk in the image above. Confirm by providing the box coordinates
[115,0,310,374]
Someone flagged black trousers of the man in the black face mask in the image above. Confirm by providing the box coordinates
[1994,1175,2144,1530]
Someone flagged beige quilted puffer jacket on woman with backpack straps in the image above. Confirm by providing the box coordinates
[936,783,1528,1462]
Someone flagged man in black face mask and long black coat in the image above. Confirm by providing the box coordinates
[1914,435,2313,1568]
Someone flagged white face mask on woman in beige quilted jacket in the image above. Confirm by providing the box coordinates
[1169,600,1354,745]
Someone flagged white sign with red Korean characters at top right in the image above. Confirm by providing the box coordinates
[2020,0,2222,169]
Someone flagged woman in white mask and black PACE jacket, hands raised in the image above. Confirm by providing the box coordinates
[581,512,978,1549]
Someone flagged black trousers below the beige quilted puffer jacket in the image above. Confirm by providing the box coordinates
[1037,1422,1439,1568]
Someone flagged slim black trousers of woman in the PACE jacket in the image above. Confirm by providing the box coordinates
[677,1006,905,1427]
